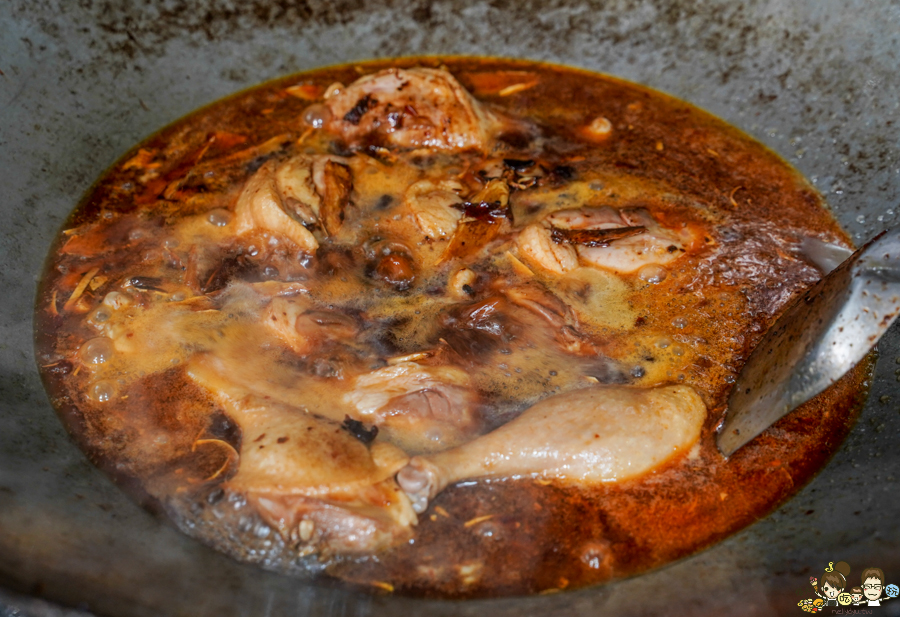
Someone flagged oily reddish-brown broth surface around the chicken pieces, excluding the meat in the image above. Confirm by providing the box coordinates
[37,58,870,597]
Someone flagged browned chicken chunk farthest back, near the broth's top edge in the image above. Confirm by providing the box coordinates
[325,68,501,151]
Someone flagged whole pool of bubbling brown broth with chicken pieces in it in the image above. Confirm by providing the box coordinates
[36,58,871,598]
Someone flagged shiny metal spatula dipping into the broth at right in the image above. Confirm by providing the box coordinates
[716,227,900,457]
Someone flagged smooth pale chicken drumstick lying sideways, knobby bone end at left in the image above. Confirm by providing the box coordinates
[397,386,706,512]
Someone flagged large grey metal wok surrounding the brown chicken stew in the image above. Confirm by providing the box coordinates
[0,0,900,617]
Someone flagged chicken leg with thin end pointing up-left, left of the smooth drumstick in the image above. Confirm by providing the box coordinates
[188,356,416,553]
